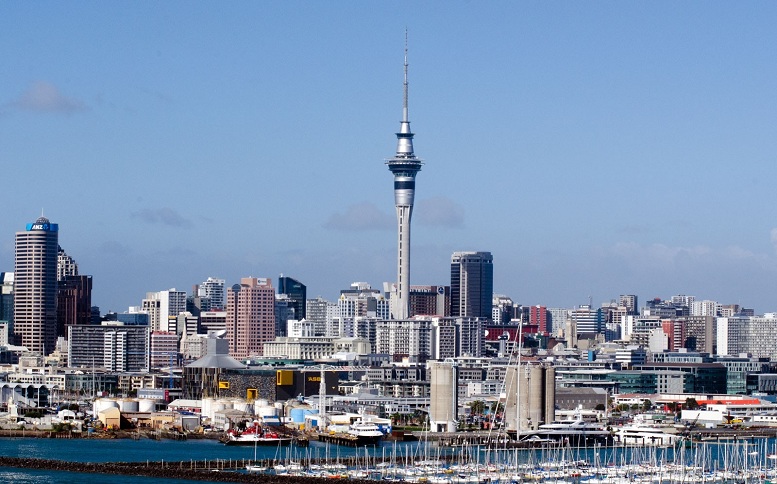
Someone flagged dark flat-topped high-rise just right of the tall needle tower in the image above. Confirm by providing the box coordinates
[451,252,494,320]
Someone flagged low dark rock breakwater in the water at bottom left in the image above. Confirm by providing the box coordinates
[0,457,374,484]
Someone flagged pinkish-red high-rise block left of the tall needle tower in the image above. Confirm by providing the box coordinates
[227,277,275,358]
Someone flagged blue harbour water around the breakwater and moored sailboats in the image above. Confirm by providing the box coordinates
[0,438,777,484]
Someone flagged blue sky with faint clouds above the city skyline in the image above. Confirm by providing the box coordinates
[0,1,777,313]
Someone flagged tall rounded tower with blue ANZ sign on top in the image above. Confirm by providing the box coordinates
[14,217,59,355]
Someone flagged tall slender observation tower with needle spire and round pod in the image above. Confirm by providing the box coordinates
[386,36,423,319]
